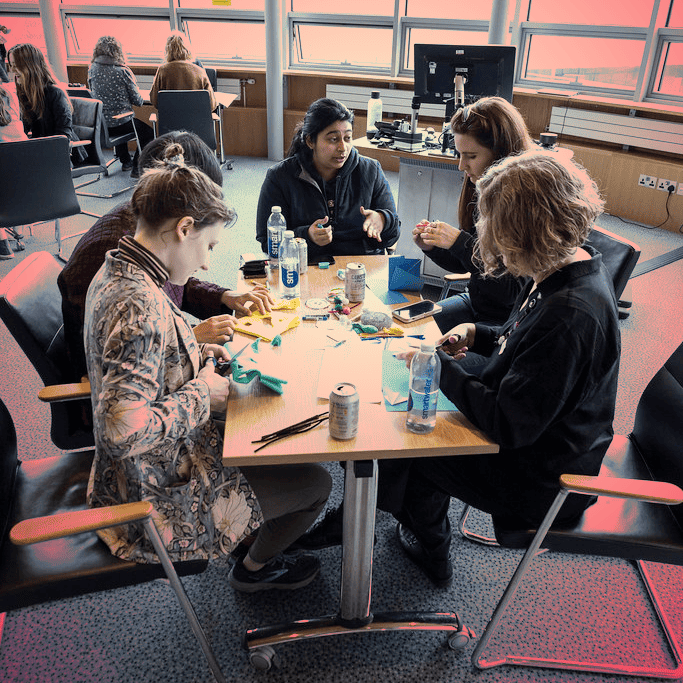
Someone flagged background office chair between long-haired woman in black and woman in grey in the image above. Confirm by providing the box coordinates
[67,91,141,199]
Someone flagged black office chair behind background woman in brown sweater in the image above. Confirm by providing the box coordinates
[150,90,224,164]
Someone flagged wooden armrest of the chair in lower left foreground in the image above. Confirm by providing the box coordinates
[10,501,153,545]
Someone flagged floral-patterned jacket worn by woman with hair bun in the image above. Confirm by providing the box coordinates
[85,251,262,562]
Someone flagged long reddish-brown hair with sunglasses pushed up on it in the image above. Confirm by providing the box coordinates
[451,97,533,232]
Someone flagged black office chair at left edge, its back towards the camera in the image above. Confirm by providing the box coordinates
[0,135,89,260]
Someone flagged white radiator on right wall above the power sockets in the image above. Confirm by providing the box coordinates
[548,107,683,154]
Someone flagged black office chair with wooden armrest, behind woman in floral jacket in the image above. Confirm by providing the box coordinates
[0,252,94,450]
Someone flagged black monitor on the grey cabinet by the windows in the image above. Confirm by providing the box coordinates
[415,45,516,104]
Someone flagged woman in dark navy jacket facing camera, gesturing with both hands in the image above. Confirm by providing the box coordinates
[256,98,400,259]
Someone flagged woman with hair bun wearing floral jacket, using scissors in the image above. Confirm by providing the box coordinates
[85,144,331,592]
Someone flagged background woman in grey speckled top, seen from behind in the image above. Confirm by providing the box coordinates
[88,36,154,178]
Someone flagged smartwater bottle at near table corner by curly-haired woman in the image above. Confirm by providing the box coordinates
[406,342,441,434]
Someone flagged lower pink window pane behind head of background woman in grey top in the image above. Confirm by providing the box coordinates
[66,15,171,59]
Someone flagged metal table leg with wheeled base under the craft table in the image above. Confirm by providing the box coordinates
[242,460,474,670]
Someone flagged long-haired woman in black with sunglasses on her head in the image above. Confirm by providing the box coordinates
[413,97,534,336]
